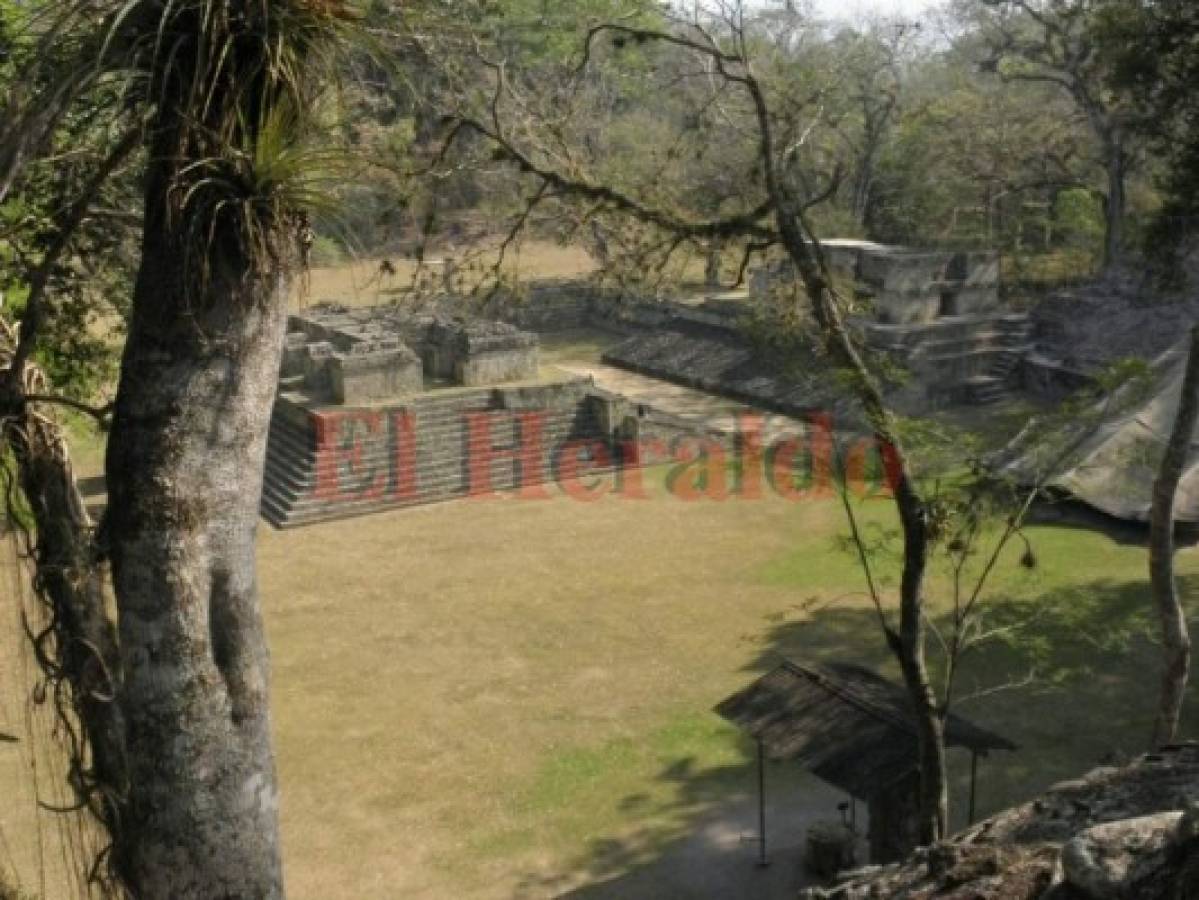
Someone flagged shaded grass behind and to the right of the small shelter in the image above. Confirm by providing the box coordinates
[752,575,1199,827]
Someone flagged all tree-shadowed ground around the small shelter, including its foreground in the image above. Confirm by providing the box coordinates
[522,576,1199,900]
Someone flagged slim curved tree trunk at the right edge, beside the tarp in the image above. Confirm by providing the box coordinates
[1149,326,1199,747]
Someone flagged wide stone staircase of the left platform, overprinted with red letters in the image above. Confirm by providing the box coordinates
[261,386,617,528]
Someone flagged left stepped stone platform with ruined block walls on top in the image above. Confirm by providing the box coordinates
[261,304,614,526]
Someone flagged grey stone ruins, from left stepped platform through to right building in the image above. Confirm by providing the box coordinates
[261,241,1026,527]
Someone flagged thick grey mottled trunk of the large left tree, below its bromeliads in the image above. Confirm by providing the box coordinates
[103,160,294,900]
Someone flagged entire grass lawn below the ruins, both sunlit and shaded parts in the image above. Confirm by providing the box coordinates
[250,472,1199,898]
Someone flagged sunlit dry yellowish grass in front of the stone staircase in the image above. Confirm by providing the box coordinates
[260,474,853,898]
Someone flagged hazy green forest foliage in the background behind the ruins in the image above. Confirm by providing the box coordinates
[306,0,1160,280]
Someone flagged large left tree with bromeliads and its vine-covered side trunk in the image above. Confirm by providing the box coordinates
[0,0,357,898]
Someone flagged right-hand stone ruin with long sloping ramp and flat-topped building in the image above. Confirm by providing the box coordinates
[604,241,1030,416]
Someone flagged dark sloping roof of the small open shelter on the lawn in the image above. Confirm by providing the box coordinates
[716,660,1016,801]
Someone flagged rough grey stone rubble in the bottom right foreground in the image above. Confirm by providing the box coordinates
[800,743,1199,900]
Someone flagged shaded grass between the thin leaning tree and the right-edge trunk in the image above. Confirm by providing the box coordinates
[940,575,1199,814]
